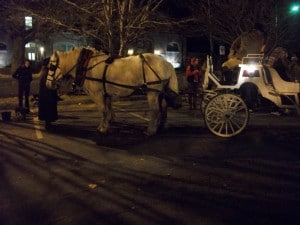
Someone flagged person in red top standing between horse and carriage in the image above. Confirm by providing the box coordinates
[186,57,203,109]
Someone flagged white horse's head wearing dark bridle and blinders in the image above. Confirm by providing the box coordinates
[46,52,63,89]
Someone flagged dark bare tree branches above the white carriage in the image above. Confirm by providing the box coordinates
[187,0,287,54]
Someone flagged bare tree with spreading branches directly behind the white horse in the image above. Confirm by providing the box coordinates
[11,0,169,56]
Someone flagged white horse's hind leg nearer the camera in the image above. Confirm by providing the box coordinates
[145,92,160,136]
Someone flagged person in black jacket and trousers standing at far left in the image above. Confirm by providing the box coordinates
[12,59,32,113]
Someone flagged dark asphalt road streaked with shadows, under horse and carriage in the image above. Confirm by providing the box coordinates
[0,99,300,225]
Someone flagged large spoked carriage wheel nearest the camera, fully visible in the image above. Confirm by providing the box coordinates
[204,94,249,137]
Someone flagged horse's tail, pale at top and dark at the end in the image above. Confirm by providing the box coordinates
[165,64,182,109]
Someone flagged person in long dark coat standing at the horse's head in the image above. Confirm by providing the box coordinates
[38,58,58,129]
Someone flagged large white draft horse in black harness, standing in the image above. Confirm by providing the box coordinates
[46,47,181,135]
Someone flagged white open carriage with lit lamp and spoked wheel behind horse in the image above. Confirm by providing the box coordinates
[201,54,300,137]
